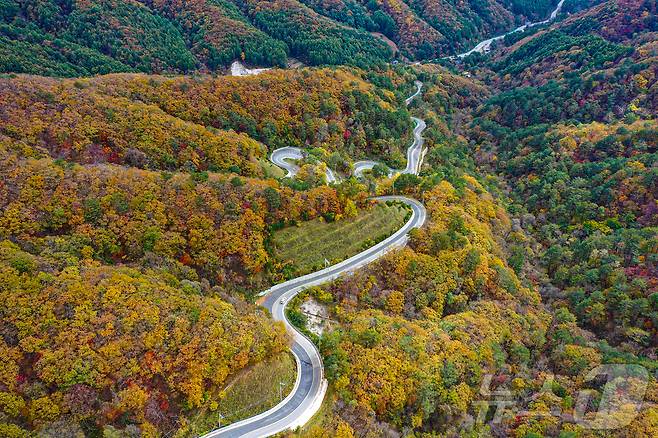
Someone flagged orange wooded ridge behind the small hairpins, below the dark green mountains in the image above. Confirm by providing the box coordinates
[0,69,412,176]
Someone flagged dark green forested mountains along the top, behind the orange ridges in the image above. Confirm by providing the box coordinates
[0,0,555,76]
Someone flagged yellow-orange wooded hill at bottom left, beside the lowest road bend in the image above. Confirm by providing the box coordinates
[0,239,287,436]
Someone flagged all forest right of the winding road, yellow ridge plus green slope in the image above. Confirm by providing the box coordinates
[286,0,658,437]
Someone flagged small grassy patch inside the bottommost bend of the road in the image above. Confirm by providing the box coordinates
[189,352,297,435]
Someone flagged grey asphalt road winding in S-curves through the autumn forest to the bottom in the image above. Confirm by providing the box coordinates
[203,83,427,438]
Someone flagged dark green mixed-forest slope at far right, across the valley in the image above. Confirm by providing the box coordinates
[464,1,658,357]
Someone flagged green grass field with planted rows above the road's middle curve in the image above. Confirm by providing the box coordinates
[273,204,408,275]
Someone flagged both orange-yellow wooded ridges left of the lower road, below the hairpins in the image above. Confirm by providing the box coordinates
[0,104,380,436]
